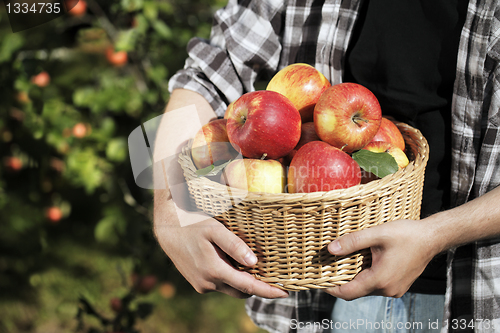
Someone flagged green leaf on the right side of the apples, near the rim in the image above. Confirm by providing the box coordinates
[352,149,399,178]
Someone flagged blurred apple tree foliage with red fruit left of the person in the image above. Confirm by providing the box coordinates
[0,0,266,333]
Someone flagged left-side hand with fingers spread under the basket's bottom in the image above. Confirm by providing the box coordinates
[155,193,288,298]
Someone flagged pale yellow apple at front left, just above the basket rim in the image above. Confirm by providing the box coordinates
[222,158,286,193]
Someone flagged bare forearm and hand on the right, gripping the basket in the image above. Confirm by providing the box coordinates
[327,187,500,300]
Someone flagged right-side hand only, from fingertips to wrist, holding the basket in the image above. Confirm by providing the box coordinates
[327,220,437,300]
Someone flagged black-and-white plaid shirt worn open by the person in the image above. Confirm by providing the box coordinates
[169,0,500,333]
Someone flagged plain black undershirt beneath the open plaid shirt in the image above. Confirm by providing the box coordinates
[344,0,468,294]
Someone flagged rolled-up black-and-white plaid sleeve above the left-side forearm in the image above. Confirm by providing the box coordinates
[169,0,284,116]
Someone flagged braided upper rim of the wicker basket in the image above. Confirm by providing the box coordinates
[179,122,429,204]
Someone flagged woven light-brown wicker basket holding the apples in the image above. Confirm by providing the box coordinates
[179,123,429,291]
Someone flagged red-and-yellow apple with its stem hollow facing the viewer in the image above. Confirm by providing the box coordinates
[314,83,382,153]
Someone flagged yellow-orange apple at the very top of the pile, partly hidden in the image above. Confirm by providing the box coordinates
[266,63,331,123]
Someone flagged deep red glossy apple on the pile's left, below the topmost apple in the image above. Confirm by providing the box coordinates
[227,90,301,160]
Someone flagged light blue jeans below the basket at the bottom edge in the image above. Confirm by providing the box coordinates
[323,293,444,333]
